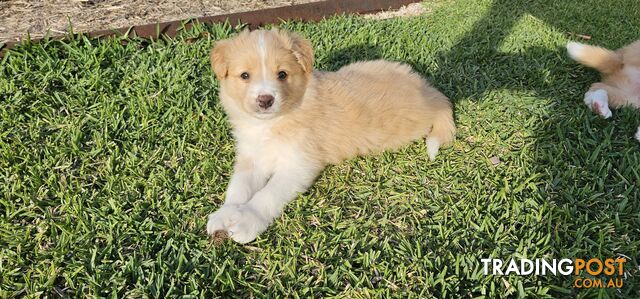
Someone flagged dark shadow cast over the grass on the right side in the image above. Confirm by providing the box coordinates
[322,0,640,298]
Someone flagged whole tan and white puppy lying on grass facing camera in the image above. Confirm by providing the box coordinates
[207,30,455,243]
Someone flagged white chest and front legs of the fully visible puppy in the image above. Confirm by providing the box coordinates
[207,119,321,243]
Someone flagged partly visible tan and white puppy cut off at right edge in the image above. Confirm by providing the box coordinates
[567,41,640,141]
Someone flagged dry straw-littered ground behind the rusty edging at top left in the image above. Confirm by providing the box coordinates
[0,0,319,42]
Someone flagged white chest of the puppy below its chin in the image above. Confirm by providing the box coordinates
[235,127,298,173]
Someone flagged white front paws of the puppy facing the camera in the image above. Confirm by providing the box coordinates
[207,205,269,244]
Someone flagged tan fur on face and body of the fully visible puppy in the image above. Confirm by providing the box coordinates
[212,30,455,164]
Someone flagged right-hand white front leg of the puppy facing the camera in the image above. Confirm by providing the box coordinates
[210,163,321,243]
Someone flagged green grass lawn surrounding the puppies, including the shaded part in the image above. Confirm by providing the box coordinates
[0,0,640,298]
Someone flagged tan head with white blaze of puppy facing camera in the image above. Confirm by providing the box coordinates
[211,29,313,119]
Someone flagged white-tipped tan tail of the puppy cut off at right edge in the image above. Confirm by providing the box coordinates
[567,42,622,74]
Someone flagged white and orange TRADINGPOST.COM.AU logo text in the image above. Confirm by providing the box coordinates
[480,258,627,288]
